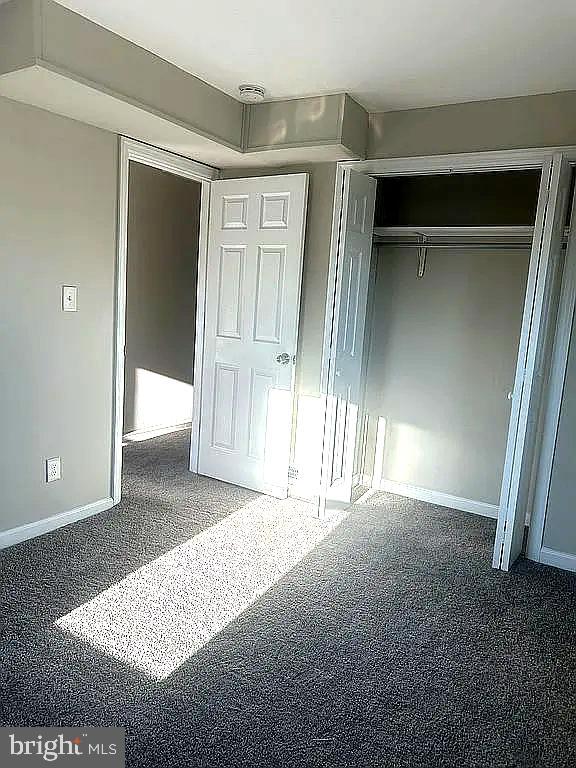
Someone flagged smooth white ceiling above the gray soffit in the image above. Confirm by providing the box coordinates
[54,0,576,111]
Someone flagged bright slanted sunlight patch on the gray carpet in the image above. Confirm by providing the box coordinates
[56,497,345,680]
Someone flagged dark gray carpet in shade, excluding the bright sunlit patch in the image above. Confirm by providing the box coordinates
[0,428,576,768]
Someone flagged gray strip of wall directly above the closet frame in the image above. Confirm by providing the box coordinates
[368,91,576,158]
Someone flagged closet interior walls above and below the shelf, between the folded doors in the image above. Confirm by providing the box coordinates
[357,171,540,516]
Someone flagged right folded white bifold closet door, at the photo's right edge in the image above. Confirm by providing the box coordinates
[492,155,570,571]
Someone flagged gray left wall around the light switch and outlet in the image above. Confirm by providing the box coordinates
[0,93,118,530]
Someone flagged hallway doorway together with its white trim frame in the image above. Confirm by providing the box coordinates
[112,138,217,504]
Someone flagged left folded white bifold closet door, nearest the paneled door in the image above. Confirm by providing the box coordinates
[322,170,376,507]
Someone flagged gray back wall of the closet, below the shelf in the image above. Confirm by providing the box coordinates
[367,247,529,504]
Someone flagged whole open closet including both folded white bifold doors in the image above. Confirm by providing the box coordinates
[323,158,573,568]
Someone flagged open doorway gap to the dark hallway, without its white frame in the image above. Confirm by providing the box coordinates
[122,161,202,510]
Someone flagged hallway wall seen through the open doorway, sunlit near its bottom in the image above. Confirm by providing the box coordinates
[124,163,202,432]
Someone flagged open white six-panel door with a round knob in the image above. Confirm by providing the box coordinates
[198,174,308,498]
